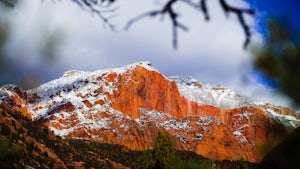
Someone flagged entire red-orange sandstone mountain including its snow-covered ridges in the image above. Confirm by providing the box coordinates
[0,63,300,163]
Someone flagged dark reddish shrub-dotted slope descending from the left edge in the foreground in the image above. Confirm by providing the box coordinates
[0,105,134,169]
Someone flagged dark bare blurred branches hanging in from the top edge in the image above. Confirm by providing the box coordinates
[72,0,254,49]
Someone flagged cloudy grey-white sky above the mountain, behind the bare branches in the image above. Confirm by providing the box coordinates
[1,0,296,106]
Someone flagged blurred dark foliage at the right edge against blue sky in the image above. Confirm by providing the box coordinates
[254,19,300,105]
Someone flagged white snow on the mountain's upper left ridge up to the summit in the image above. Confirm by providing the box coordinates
[27,62,156,119]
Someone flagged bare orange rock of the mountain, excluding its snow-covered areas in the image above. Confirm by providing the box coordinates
[0,66,289,163]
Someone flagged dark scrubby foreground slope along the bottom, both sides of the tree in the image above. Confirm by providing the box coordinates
[0,100,258,169]
